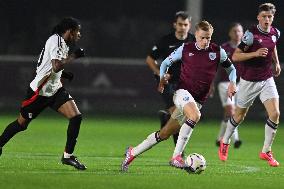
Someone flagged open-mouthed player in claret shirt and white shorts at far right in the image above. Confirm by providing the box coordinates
[218,3,281,167]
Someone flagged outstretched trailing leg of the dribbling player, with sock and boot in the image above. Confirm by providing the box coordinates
[121,118,180,171]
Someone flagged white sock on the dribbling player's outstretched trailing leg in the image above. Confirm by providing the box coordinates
[132,131,161,156]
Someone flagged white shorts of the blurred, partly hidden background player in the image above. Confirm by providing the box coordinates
[218,81,236,107]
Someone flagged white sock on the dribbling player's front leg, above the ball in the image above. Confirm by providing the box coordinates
[173,119,196,157]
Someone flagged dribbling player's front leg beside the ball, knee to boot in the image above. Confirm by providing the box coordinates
[170,102,201,168]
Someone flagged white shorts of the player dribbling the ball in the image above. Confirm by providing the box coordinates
[171,89,202,125]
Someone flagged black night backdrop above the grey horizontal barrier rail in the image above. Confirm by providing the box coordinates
[0,0,284,58]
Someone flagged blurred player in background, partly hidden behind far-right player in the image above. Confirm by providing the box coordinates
[216,23,243,148]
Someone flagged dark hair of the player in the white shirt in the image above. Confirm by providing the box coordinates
[52,17,81,35]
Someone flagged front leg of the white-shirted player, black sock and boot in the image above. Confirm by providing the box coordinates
[58,100,87,170]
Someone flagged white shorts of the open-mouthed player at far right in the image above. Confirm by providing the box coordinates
[237,77,279,108]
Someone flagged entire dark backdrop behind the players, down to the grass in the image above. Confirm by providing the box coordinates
[0,0,284,119]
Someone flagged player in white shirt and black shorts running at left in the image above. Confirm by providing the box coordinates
[0,17,87,170]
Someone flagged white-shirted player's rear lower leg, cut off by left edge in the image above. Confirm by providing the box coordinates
[0,114,30,156]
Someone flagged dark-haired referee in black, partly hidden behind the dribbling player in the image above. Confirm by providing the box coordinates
[146,11,194,151]
